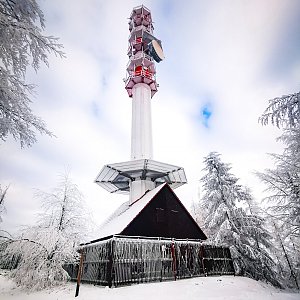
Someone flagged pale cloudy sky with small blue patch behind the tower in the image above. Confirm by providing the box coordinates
[0,0,300,232]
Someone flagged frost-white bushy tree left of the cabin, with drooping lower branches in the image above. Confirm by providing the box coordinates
[4,175,87,289]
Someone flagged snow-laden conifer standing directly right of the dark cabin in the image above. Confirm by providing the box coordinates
[200,152,280,286]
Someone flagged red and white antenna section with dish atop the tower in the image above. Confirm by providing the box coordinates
[125,5,164,98]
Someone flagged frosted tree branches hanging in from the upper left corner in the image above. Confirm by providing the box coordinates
[0,0,64,147]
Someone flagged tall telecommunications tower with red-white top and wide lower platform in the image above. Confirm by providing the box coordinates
[96,5,186,203]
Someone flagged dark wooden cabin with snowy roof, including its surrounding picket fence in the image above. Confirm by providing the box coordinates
[66,183,234,287]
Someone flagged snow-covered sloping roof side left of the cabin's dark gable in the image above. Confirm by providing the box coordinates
[92,183,167,241]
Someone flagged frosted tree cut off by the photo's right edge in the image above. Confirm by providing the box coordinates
[257,92,300,289]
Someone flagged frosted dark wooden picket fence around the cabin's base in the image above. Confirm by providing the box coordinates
[65,236,234,287]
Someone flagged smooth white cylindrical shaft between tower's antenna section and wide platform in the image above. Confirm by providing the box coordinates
[131,83,153,160]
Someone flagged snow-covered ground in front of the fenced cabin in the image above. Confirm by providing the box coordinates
[0,275,300,300]
